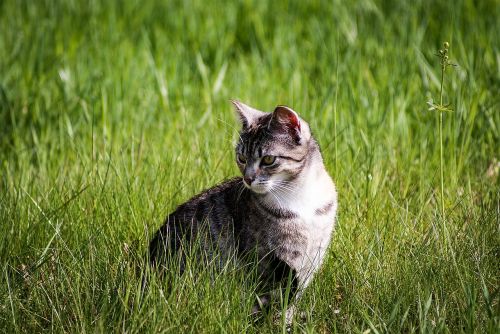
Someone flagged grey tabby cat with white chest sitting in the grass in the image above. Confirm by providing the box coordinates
[149,101,337,323]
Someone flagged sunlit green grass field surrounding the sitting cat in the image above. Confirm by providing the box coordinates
[0,0,500,333]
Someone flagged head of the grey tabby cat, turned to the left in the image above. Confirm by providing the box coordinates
[232,101,312,194]
